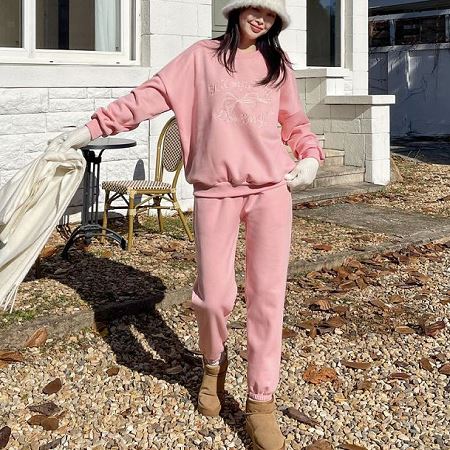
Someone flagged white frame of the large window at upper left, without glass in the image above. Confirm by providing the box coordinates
[0,0,141,66]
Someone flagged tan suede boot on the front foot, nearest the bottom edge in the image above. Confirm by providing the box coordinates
[245,397,285,450]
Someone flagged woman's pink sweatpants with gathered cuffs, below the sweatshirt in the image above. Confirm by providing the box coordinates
[192,184,292,400]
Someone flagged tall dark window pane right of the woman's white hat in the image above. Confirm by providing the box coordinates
[306,0,341,66]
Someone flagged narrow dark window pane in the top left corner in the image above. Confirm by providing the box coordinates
[0,0,23,48]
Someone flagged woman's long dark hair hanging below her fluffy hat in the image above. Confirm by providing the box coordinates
[212,8,292,88]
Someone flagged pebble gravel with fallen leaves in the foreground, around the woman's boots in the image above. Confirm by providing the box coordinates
[0,244,450,450]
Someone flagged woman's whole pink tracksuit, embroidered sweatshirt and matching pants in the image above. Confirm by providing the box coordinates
[86,39,324,400]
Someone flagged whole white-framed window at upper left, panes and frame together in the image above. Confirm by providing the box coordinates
[0,0,136,64]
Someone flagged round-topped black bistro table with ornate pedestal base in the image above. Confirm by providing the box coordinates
[61,137,136,259]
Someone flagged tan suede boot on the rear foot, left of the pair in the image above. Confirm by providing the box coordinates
[197,348,228,416]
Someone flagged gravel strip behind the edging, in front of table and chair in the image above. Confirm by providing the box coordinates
[0,216,391,328]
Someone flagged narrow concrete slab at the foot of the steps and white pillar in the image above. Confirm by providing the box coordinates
[292,182,385,206]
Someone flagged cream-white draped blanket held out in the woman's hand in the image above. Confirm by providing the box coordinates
[0,148,86,312]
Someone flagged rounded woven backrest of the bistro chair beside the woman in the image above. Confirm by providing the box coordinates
[155,116,183,184]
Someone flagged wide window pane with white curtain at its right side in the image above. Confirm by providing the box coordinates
[36,0,120,52]
